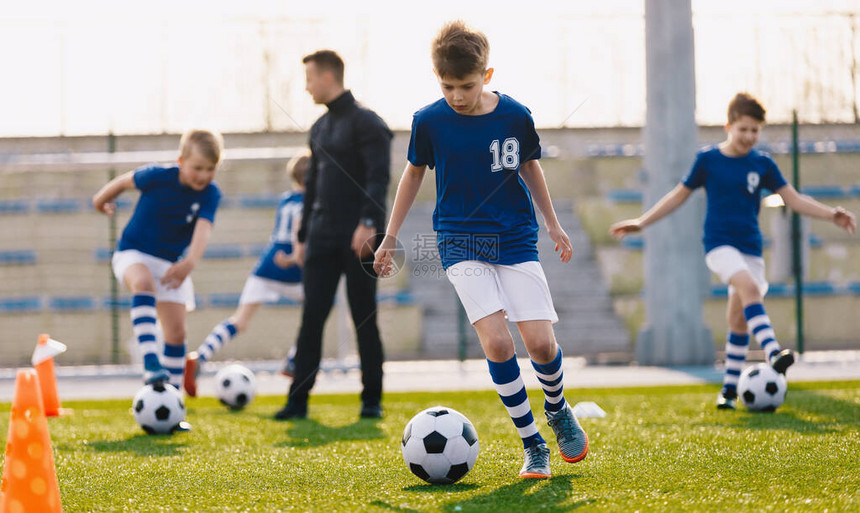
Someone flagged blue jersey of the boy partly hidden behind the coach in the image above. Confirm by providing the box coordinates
[251,192,304,283]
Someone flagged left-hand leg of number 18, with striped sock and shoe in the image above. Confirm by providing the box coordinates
[475,311,550,478]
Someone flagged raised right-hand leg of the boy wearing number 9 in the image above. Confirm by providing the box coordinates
[729,271,794,374]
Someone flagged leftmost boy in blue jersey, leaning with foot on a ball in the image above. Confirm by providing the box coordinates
[93,130,223,400]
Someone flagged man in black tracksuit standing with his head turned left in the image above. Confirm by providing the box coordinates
[275,50,392,420]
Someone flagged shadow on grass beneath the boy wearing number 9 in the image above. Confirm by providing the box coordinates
[700,390,860,435]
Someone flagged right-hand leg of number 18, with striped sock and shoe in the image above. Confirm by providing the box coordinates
[517,321,588,463]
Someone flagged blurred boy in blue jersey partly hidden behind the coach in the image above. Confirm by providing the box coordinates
[183,153,310,397]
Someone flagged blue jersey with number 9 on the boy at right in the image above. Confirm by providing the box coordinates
[683,146,786,256]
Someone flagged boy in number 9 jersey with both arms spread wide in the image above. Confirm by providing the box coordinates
[609,93,856,410]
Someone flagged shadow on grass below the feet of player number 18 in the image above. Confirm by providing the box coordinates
[442,474,595,513]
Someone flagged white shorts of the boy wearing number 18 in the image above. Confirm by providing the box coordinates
[445,260,558,324]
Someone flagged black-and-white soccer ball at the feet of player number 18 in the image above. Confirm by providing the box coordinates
[400,406,479,484]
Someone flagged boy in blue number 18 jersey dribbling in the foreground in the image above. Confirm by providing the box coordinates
[374,21,588,478]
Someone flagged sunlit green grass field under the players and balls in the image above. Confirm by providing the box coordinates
[0,382,860,512]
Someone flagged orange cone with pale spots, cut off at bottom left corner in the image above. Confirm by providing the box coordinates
[0,369,63,513]
